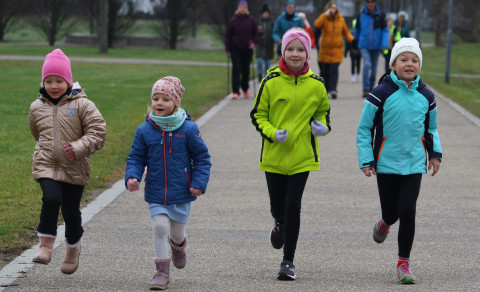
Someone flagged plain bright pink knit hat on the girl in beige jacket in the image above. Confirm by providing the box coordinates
[42,49,73,85]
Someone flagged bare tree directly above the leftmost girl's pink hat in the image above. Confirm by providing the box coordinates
[22,0,78,46]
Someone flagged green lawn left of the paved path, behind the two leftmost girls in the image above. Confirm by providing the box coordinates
[0,46,226,267]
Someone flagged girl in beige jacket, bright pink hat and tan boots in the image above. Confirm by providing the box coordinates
[28,49,106,274]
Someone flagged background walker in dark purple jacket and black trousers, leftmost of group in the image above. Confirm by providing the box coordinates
[225,0,258,99]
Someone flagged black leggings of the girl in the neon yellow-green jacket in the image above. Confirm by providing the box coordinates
[265,172,309,262]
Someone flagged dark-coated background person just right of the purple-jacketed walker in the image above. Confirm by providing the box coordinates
[255,3,273,82]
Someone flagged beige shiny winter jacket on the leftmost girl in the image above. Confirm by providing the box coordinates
[28,89,107,185]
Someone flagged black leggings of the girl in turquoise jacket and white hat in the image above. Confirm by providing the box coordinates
[377,173,422,258]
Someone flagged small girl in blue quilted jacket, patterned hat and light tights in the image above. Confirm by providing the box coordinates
[125,76,211,290]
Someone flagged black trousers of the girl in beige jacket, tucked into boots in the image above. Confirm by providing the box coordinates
[37,178,85,244]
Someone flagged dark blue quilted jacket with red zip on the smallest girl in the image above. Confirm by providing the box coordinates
[125,115,211,205]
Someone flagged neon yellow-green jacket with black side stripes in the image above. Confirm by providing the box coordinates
[250,66,331,175]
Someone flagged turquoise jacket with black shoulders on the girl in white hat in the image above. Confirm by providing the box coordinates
[357,72,442,175]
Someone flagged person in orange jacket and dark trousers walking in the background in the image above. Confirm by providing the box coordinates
[313,1,355,99]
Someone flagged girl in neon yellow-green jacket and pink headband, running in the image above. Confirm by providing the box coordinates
[250,28,330,280]
